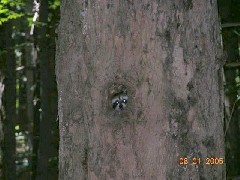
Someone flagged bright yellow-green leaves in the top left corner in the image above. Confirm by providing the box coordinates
[0,0,24,26]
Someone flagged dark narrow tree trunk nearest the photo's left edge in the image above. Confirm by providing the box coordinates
[3,22,16,180]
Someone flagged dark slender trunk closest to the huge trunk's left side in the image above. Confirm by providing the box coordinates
[36,1,51,177]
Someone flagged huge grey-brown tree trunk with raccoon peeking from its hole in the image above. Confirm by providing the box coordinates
[56,0,225,180]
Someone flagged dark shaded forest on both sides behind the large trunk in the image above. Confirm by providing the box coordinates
[0,0,240,179]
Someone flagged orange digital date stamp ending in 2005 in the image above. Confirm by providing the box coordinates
[178,157,224,165]
